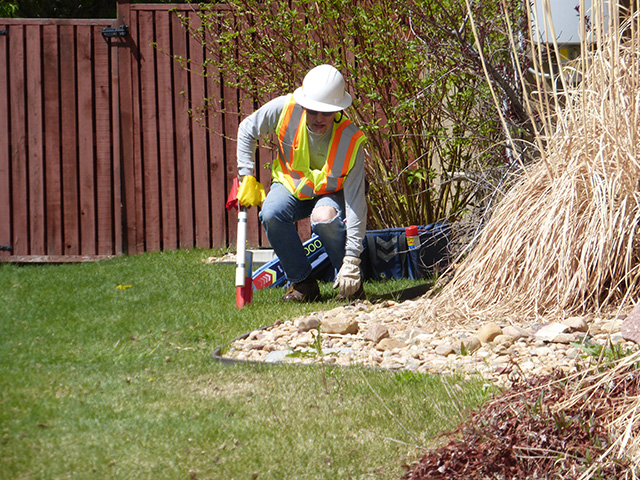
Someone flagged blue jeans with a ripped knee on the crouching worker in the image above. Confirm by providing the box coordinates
[260,183,347,283]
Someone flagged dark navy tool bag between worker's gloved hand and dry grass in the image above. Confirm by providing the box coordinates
[360,223,450,280]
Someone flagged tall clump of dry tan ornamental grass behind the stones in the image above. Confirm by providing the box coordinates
[423,0,640,322]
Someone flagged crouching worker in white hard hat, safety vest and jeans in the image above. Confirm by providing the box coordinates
[237,65,367,302]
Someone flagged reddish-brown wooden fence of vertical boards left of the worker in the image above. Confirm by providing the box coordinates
[0,0,288,262]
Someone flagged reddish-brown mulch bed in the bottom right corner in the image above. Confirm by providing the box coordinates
[403,373,640,480]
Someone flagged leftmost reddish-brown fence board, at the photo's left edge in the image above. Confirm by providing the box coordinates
[0,23,12,259]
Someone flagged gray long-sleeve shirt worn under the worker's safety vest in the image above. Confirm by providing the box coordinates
[237,96,367,257]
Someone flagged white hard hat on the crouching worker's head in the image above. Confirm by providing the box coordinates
[293,65,352,112]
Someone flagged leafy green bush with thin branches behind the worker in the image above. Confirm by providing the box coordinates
[178,0,528,228]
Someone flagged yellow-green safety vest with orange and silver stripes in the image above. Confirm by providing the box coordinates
[272,95,366,200]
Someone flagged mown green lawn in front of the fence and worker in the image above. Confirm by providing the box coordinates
[0,250,489,480]
